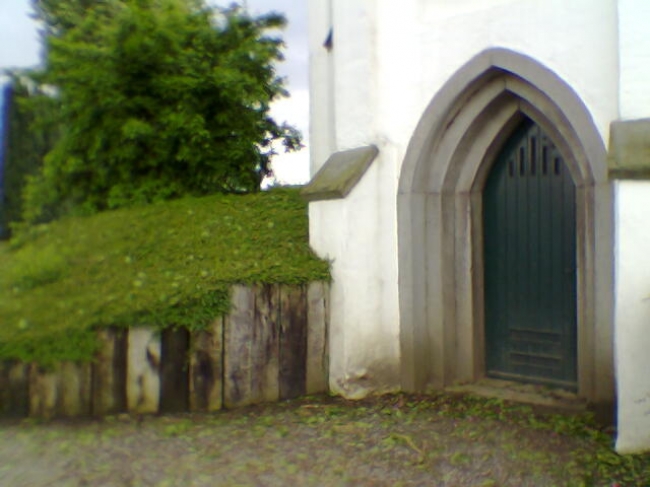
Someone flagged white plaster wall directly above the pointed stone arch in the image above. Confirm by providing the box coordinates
[372,0,616,149]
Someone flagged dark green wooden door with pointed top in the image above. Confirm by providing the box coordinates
[483,120,577,388]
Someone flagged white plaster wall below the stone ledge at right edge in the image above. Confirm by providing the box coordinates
[615,181,650,453]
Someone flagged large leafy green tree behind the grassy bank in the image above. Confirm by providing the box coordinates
[24,0,300,221]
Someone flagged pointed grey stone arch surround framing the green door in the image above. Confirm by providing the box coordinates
[397,49,614,403]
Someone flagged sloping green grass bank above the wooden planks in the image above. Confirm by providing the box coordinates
[0,189,329,365]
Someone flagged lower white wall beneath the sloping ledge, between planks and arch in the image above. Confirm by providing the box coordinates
[309,150,399,398]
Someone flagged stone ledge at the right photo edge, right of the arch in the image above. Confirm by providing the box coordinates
[608,118,650,179]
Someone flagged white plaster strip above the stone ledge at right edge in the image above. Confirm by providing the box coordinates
[618,0,650,120]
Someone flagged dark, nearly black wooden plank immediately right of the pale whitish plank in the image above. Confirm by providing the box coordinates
[158,328,190,413]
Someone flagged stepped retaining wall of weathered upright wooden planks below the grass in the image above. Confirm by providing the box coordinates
[0,282,329,418]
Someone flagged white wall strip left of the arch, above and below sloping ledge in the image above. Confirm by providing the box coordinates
[310,0,401,397]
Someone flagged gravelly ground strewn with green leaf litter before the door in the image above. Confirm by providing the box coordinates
[0,395,650,487]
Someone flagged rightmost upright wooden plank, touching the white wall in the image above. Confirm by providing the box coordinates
[306,282,329,394]
